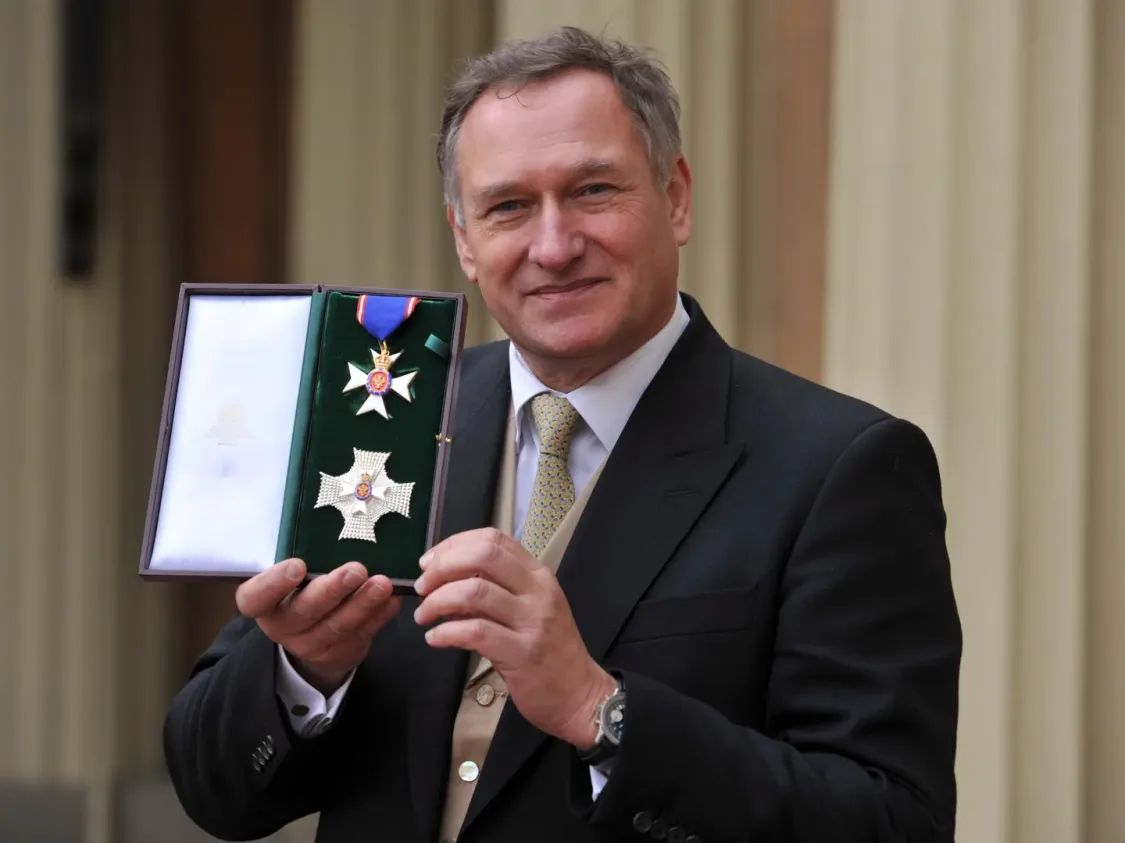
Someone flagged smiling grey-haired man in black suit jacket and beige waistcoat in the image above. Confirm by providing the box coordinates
[165,29,961,843]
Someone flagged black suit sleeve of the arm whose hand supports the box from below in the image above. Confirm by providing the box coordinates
[164,618,347,841]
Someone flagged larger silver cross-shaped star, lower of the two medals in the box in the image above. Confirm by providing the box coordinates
[316,448,414,542]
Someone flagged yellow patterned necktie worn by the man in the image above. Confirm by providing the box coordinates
[522,393,579,556]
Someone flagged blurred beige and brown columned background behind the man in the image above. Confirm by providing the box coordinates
[0,0,1125,843]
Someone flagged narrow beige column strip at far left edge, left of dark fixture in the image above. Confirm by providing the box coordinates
[0,0,61,777]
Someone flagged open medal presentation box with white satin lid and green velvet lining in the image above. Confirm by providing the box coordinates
[140,284,466,593]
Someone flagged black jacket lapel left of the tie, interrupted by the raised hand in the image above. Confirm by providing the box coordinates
[401,343,511,841]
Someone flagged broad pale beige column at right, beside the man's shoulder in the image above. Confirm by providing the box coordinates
[825,0,1125,843]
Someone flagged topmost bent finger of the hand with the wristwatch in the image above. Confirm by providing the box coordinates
[415,528,534,597]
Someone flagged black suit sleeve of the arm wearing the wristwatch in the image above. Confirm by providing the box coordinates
[570,420,962,843]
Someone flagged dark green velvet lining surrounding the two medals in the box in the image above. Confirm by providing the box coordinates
[293,292,457,580]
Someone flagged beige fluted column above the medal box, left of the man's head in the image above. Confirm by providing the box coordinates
[291,0,495,343]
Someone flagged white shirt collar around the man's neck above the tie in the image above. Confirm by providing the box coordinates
[509,295,690,451]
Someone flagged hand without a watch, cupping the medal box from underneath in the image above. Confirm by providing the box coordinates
[235,559,403,694]
